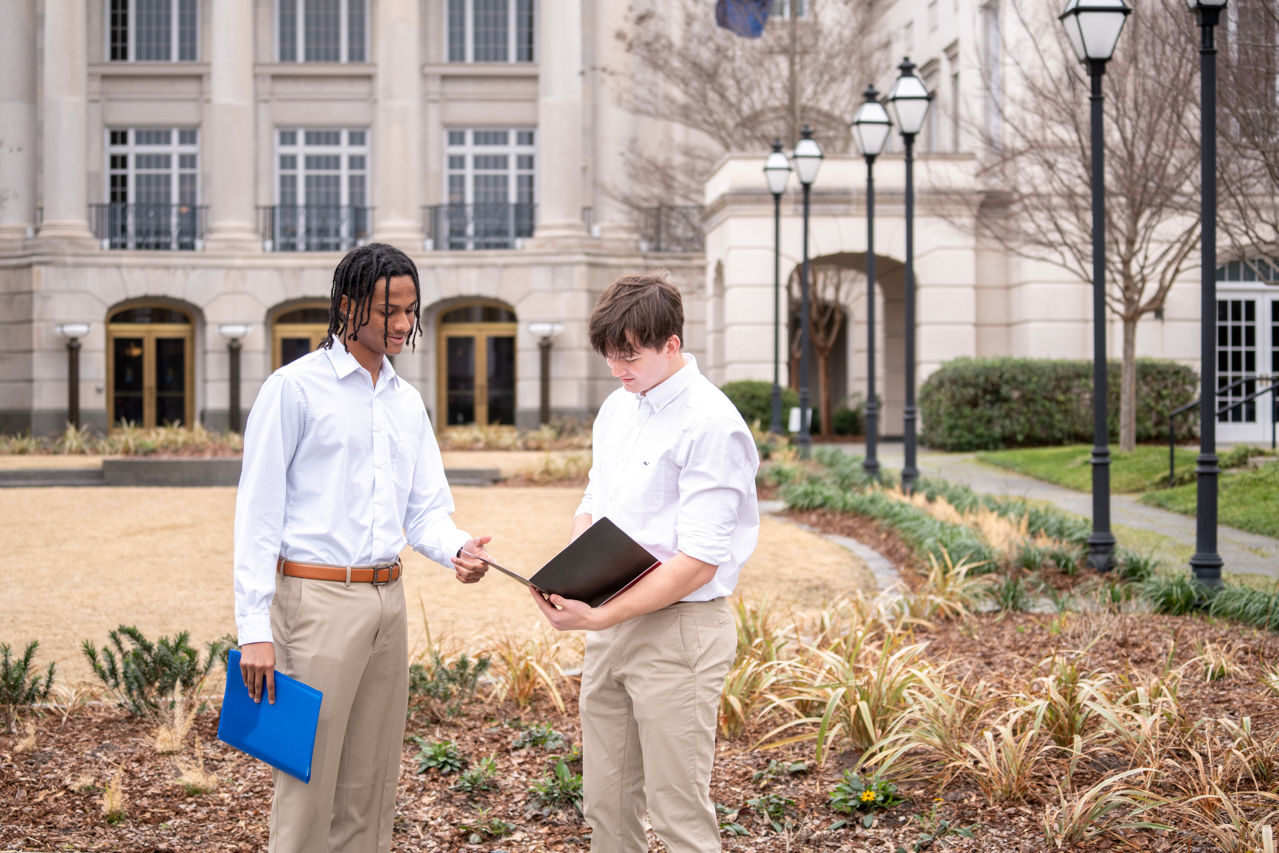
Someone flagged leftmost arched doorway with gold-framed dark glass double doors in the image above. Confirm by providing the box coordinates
[106,304,196,427]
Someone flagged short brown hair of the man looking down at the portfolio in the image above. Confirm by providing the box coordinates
[590,271,684,357]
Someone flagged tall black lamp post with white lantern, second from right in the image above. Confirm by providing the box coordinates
[1059,0,1132,572]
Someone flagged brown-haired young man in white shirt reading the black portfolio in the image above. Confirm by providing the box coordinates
[533,269,760,853]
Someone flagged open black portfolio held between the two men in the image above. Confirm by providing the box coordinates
[468,518,661,607]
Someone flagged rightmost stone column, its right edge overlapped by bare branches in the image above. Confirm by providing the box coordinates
[592,0,640,242]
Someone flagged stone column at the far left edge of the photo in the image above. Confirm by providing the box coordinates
[0,0,36,244]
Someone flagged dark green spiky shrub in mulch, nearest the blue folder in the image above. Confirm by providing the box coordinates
[81,625,225,717]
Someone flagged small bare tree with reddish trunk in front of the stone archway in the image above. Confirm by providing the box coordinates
[787,263,866,436]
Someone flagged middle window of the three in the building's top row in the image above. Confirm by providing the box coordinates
[276,0,368,63]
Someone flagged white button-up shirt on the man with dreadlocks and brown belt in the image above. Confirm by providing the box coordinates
[235,340,471,645]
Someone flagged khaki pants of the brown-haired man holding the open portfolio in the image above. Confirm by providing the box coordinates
[579,599,737,853]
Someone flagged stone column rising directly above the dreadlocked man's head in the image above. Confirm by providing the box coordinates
[372,0,422,246]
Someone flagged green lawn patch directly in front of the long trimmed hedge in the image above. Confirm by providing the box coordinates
[977,444,1198,494]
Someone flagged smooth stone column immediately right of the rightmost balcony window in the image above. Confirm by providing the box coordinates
[535,0,586,242]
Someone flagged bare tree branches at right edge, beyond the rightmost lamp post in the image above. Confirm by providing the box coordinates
[1216,0,1279,264]
